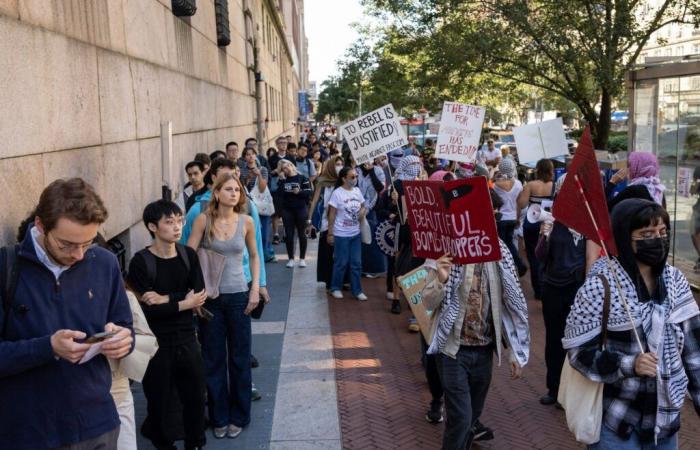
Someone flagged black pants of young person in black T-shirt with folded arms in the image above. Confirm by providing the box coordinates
[143,333,206,449]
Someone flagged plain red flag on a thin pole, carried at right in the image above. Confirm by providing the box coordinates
[552,127,617,256]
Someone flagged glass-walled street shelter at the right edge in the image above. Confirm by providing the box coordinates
[630,64,700,286]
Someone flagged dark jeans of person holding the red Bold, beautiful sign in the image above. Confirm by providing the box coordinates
[437,345,493,450]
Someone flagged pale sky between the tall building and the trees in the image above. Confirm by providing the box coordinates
[304,0,362,89]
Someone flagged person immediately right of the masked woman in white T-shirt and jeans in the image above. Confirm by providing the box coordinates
[356,163,386,278]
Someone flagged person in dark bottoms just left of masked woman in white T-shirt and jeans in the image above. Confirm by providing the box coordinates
[306,155,344,290]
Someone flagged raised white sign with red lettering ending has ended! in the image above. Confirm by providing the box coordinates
[435,102,486,163]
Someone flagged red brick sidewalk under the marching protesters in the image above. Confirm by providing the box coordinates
[328,279,700,450]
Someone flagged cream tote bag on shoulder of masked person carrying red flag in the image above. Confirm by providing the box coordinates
[557,275,610,444]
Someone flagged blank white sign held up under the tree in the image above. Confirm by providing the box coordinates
[513,117,569,164]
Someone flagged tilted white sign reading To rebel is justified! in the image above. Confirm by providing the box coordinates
[340,104,408,165]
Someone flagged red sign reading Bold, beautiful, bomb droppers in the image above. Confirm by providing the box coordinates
[403,177,501,264]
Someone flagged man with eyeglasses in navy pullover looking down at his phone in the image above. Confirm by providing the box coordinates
[0,178,133,450]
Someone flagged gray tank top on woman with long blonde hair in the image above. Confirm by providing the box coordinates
[205,215,248,294]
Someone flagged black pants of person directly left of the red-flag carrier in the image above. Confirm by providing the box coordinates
[542,282,581,398]
